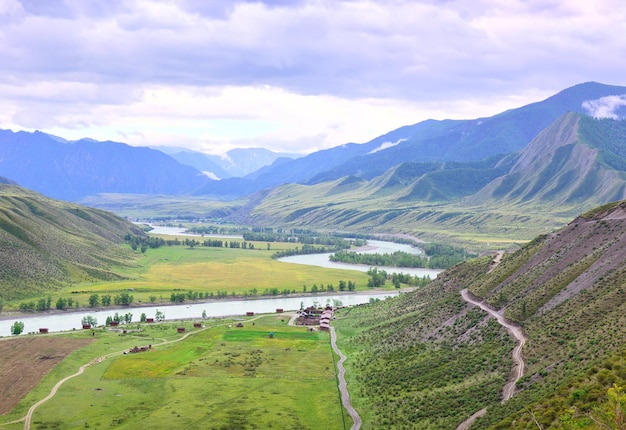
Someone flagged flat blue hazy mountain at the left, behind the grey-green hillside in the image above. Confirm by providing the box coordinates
[0,130,207,200]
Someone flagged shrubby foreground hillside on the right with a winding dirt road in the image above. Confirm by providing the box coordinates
[335,201,626,429]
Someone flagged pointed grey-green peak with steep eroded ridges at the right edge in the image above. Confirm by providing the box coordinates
[470,113,626,211]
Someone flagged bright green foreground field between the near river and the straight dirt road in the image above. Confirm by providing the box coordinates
[0,315,350,429]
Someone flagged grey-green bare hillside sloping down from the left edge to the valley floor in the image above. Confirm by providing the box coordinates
[0,184,142,300]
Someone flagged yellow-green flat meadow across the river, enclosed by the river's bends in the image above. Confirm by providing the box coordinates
[4,237,367,310]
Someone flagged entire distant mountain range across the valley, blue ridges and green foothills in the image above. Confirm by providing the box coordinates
[0,82,626,240]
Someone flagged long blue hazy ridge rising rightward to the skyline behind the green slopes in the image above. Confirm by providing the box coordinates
[198,82,626,196]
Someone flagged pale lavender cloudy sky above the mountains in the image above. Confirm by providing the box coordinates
[0,0,626,154]
